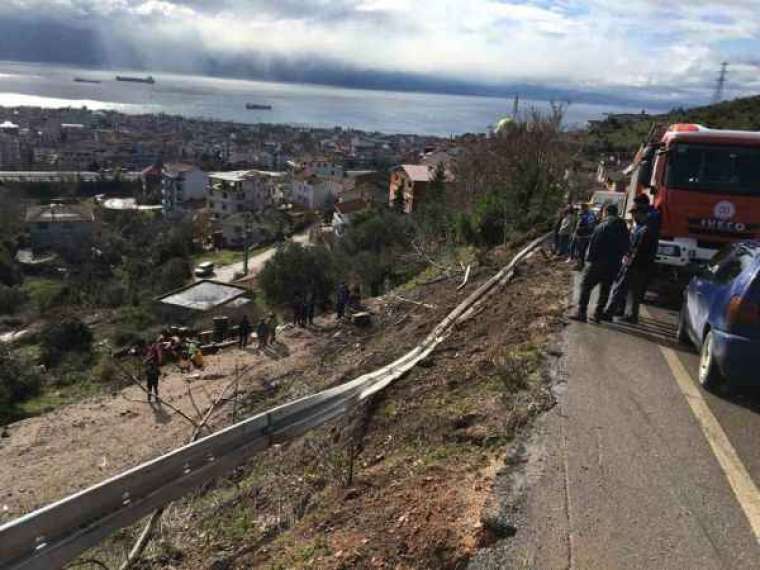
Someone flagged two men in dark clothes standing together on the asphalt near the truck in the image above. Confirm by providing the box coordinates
[572,194,660,324]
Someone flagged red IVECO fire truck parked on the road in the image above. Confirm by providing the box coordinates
[627,124,760,270]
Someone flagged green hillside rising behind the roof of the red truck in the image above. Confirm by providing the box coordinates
[588,95,760,153]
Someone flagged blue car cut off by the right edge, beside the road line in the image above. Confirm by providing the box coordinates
[678,237,760,390]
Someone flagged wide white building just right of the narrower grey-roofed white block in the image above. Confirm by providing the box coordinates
[206,170,285,220]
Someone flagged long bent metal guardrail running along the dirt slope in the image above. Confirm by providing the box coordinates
[0,232,548,570]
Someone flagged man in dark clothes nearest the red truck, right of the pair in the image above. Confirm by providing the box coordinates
[602,203,657,324]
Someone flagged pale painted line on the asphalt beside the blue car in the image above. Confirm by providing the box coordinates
[660,312,760,545]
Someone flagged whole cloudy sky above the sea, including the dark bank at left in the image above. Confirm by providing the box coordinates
[0,0,760,105]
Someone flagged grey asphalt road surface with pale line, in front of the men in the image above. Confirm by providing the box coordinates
[473,274,760,569]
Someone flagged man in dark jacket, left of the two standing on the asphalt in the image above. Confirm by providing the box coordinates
[572,204,630,322]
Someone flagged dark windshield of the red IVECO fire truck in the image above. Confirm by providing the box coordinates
[666,144,760,196]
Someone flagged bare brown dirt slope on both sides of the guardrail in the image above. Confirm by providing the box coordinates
[0,244,568,569]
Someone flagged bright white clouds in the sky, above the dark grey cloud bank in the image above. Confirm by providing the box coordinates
[0,0,760,99]
